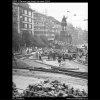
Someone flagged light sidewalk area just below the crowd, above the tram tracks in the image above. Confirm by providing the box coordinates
[15,54,88,72]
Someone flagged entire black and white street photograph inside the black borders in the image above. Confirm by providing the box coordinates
[12,2,88,100]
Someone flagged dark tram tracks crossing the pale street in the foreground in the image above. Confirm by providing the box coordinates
[14,54,88,79]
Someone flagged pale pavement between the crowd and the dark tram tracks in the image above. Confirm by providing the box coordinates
[14,54,88,72]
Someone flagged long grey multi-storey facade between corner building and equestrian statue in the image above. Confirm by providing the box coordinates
[34,12,61,38]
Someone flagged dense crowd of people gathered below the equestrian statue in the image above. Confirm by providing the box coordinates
[34,48,88,65]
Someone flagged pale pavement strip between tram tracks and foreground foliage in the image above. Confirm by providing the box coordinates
[13,69,88,91]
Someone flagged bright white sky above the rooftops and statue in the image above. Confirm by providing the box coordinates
[28,3,88,30]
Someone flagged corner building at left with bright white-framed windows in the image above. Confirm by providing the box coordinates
[13,3,34,34]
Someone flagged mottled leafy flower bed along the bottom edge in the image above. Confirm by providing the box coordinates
[13,80,88,98]
